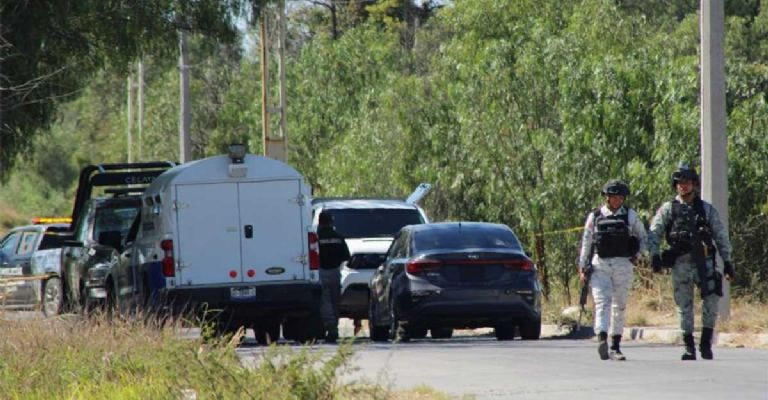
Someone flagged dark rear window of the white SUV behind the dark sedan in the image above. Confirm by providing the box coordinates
[323,208,424,239]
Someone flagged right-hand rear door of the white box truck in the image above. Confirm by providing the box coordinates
[239,180,309,282]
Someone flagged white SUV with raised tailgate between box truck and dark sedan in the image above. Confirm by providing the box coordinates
[312,183,431,320]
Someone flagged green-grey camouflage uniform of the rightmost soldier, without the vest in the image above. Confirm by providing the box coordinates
[648,196,731,335]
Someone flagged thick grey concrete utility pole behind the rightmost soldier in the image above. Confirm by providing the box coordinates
[700,0,731,321]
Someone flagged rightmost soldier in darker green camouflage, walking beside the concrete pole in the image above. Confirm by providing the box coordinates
[648,162,733,360]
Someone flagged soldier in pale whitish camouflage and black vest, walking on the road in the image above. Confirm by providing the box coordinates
[579,180,645,361]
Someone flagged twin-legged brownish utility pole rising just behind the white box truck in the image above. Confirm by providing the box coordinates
[259,0,287,161]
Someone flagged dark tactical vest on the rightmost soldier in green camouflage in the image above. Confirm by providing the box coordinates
[666,197,714,254]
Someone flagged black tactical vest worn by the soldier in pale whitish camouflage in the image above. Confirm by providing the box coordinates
[593,209,640,258]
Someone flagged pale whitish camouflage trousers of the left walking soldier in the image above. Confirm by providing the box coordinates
[589,257,634,336]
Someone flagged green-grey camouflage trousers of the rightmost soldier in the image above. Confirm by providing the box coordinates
[672,255,720,335]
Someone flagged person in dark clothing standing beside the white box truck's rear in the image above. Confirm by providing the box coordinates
[317,212,349,343]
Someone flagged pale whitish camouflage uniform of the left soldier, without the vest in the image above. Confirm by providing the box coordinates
[579,206,646,336]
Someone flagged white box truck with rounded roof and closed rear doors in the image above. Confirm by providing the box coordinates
[111,149,322,343]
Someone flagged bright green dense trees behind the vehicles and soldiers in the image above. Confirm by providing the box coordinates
[0,0,768,297]
